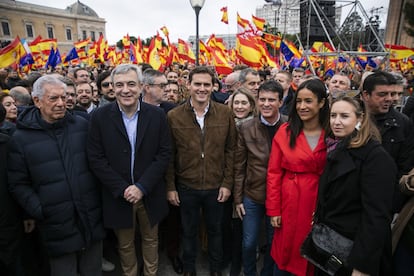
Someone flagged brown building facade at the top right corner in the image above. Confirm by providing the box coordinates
[385,0,414,48]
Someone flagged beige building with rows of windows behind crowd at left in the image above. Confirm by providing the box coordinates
[0,0,106,53]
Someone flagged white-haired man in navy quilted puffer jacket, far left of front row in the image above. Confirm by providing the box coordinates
[8,75,104,276]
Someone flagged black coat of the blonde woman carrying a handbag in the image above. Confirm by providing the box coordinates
[315,141,397,275]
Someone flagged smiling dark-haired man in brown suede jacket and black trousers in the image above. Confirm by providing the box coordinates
[166,66,236,275]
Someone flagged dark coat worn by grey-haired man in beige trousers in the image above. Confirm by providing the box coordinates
[88,102,171,228]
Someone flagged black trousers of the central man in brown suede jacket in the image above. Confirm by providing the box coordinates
[177,184,224,272]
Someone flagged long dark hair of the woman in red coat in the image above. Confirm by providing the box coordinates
[287,79,329,148]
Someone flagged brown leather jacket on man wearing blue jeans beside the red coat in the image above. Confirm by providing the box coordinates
[233,116,286,204]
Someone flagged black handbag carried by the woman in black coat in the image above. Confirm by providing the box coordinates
[300,223,354,275]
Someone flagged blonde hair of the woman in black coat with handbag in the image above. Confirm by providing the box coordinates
[329,95,381,148]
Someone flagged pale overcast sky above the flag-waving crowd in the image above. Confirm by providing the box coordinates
[23,0,389,44]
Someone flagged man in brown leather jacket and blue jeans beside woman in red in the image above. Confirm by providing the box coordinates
[234,80,286,276]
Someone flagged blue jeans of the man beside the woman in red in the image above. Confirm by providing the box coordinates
[242,196,275,276]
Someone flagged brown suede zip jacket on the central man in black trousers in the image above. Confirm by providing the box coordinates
[166,101,236,191]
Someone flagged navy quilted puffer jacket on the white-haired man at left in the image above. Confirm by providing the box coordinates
[8,107,104,256]
